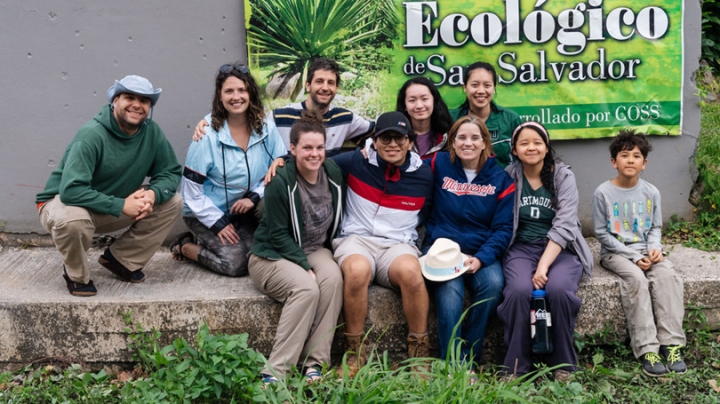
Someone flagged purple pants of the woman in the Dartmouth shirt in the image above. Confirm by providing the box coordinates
[497,241,582,376]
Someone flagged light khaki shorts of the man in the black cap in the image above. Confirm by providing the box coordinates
[332,236,420,290]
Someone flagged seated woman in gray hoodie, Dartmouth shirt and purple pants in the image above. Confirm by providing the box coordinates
[498,122,593,380]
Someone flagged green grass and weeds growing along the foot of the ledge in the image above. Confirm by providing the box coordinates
[0,305,720,404]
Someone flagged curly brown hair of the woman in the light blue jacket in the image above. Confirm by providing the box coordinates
[210,62,265,132]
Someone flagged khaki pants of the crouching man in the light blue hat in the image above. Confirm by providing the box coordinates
[39,194,183,283]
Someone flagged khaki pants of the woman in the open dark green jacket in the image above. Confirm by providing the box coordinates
[248,248,343,377]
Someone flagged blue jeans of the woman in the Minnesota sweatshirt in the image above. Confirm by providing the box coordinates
[433,261,504,363]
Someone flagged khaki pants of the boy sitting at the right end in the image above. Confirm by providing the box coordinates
[600,254,685,358]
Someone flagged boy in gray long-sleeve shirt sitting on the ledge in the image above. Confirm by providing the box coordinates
[593,130,686,376]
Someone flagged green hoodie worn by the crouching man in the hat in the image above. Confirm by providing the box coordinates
[35,105,182,217]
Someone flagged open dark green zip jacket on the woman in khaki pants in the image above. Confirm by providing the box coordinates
[251,159,342,270]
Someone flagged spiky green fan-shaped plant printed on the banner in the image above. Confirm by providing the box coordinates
[248,0,398,98]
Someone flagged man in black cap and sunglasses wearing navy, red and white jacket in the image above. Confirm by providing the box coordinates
[333,112,433,373]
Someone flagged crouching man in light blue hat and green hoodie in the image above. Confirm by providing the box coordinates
[35,76,182,296]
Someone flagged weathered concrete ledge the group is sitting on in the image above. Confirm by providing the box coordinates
[0,240,720,369]
